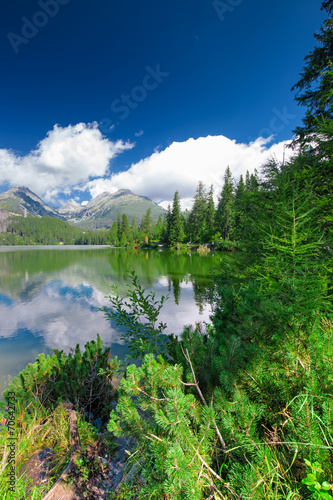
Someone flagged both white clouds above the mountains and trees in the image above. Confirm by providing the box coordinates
[0,123,292,209]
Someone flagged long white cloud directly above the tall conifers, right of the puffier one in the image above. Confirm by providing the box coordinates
[83,135,292,209]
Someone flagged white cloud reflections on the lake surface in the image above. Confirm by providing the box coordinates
[0,274,211,352]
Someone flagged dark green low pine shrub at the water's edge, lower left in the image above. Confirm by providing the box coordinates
[4,335,119,421]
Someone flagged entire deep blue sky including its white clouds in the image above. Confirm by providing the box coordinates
[0,0,324,206]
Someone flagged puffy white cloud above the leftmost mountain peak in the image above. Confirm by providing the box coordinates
[0,123,133,203]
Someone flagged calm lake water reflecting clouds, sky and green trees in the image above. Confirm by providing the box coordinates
[0,246,219,395]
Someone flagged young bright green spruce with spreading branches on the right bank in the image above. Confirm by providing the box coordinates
[261,182,327,324]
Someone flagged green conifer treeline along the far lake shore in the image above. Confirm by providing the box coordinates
[0,167,260,249]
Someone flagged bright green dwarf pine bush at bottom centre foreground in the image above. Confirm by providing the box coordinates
[108,355,227,500]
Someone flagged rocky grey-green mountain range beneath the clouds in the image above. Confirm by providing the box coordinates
[0,186,166,229]
